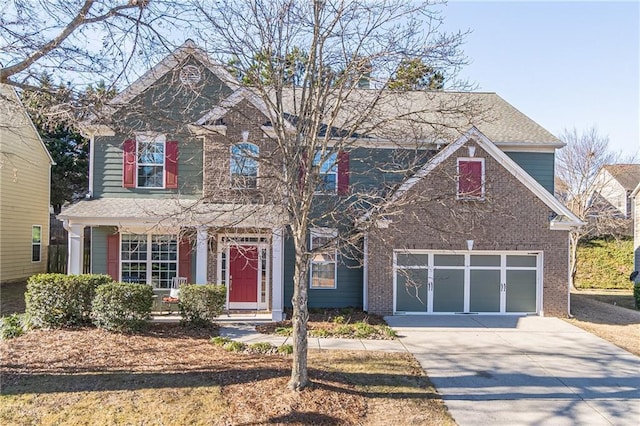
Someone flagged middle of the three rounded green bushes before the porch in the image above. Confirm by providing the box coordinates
[93,283,153,332]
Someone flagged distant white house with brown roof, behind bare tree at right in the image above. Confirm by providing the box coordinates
[594,164,640,219]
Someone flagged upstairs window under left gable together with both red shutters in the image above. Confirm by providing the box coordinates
[122,134,178,189]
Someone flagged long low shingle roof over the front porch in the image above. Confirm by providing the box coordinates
[58,198,283,228]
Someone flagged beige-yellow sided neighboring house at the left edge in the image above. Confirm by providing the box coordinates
[0,84,53,282]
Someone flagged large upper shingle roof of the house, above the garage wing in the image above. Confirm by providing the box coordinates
[276,89,564,147]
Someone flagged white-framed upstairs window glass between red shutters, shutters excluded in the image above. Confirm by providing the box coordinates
[136,135,165,188]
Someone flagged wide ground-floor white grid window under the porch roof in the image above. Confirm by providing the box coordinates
[120,234,178,289]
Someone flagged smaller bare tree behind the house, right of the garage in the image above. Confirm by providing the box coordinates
[556,127,629,286]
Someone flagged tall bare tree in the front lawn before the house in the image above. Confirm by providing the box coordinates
[189,0,472,390]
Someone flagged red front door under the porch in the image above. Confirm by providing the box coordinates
[229,246,258,303]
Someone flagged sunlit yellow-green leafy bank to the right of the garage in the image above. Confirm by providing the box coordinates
[576,238,633,290]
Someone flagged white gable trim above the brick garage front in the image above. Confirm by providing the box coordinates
[380,127,585,230]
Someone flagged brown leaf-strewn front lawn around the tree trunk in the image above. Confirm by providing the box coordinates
[0,324,454,425]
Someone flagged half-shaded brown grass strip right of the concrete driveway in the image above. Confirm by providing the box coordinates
[567,292,640,356]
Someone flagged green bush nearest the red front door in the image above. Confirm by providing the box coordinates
[178,284,227,327]
